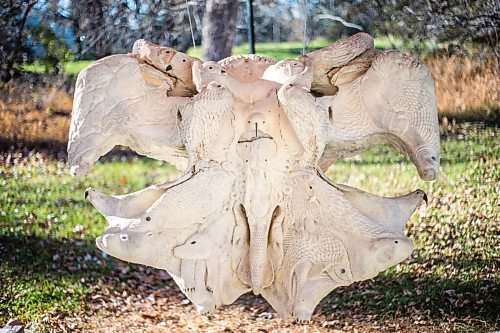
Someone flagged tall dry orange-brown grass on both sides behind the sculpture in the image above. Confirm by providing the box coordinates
[0,56,500,147]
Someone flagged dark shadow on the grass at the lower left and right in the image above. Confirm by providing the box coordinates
[0,235,500,328]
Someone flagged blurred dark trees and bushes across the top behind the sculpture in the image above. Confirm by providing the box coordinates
[0,0,500,82]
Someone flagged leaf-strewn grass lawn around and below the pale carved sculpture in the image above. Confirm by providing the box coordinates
[0,124,500,332]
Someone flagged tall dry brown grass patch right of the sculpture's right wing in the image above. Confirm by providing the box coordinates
[427,56,500,121]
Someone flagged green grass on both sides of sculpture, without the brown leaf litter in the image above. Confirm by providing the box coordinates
[0,125,500,331]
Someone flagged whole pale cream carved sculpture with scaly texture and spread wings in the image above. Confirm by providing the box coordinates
[68,34,439,320]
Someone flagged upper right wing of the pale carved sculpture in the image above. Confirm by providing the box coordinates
[307,34,440,180]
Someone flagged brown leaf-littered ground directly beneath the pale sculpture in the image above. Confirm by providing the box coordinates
[38,265,494,333]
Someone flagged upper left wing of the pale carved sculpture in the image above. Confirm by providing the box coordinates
[68,40,201,175]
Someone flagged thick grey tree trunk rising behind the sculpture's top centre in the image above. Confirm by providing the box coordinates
[201,0,238,61]
